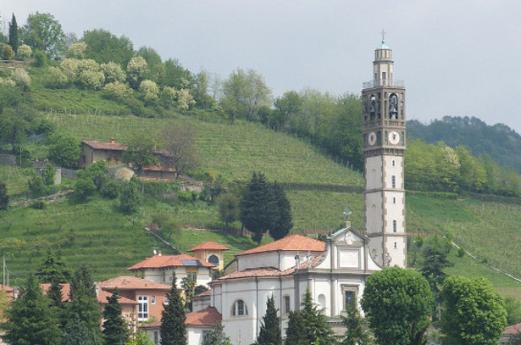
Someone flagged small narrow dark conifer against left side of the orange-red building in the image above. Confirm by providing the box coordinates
[103,291,128,345]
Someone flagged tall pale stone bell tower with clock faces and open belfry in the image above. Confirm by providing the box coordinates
[362,33,407,267]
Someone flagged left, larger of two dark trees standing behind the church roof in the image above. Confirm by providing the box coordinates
[240,172,275,243]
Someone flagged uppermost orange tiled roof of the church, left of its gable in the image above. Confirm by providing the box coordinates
[237,235,326,255]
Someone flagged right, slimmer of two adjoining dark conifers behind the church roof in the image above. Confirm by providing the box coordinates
[269,182,293,240]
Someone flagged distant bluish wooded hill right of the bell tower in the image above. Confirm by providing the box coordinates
[407,116,521,172]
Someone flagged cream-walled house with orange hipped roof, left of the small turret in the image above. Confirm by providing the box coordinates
[129,254,215,287]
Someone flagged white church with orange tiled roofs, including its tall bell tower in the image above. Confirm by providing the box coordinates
[188,41,407,345]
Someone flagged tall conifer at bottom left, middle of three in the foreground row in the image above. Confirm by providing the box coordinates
[65,266,102,345]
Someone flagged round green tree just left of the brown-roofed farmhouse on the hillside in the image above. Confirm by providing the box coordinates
[49,133,81,168]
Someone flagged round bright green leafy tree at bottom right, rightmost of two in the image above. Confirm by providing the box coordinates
[441,277,507,345]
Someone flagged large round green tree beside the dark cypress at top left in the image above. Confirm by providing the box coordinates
[22,12,65,58]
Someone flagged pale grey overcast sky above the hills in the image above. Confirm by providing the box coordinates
[0,0,521,132]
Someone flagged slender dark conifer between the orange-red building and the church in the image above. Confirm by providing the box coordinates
[160,274,187,345]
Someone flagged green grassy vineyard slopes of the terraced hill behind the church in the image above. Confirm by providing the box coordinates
[0,113,521,296]
